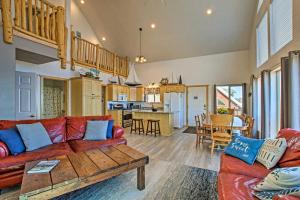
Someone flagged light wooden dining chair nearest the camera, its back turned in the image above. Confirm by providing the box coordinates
[210,114,233,155]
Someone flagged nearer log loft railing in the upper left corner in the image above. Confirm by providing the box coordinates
[1,0,66,67]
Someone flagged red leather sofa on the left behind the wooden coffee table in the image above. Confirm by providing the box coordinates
[0,116,127,189]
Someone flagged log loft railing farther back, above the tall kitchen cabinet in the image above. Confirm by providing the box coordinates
[71,31,129,77]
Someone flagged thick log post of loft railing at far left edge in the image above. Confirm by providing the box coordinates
[1,0,13,44]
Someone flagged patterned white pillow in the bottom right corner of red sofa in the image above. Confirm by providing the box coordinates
[253,167,300,191]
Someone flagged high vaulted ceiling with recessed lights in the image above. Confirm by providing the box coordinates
[75,0,257,62]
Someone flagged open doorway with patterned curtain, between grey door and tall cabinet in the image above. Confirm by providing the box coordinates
[41,77,68,119]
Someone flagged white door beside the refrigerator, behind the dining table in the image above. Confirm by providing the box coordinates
[187,86,208,126]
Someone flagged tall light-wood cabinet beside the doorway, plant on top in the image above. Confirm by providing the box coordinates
[71,78,103,116]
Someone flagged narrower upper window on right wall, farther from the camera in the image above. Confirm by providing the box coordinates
[256,13,269,67]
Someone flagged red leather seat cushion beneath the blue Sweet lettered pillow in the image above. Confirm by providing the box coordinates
[220,154,271,178]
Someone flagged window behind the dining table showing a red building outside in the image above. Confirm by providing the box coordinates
[215,85,245,115]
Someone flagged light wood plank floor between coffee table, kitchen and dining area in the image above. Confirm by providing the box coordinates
[0,129,220,200]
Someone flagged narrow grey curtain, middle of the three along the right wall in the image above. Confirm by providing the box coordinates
[260,70,271,139]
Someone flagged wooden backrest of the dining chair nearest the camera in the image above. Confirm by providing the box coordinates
[210,114,233,134]
